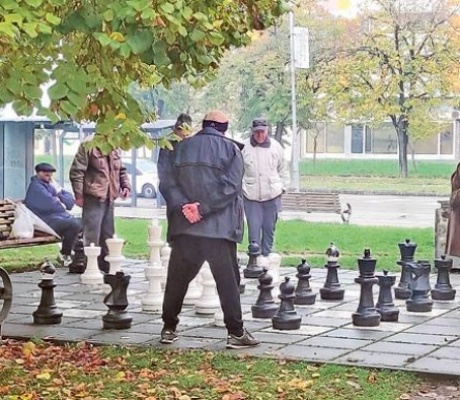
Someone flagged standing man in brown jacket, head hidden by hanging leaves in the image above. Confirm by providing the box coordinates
[69,136,131,272]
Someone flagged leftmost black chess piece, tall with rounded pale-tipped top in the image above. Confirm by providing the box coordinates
[32,260,62,325]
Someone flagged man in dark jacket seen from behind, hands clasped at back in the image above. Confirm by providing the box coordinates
[159,111,259,348]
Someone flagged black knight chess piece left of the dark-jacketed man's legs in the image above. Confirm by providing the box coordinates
[102,271,133,329]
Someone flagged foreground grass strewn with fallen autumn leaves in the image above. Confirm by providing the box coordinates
[0,341,422,400]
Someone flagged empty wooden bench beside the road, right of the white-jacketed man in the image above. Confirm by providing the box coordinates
[281,192,352,224]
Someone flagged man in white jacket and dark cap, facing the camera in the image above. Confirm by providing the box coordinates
[243,118,289,256]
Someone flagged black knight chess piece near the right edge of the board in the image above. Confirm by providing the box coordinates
[406,261,433,312]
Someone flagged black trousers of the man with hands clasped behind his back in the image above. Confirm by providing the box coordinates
[162,235,243,336]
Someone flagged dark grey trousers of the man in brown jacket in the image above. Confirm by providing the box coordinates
[82,196,115,272]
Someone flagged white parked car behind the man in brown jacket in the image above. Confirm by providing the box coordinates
[122,158,158,199]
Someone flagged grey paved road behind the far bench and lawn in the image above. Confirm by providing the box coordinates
[115,194,445,228]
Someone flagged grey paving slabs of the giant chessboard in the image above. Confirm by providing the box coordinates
[3,262,460,375]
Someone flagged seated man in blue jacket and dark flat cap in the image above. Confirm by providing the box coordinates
[24,163,82,267]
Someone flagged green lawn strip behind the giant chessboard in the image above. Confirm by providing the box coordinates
[0,218,434,271]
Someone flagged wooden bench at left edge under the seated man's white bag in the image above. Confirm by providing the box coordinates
[0,200,60,250]
